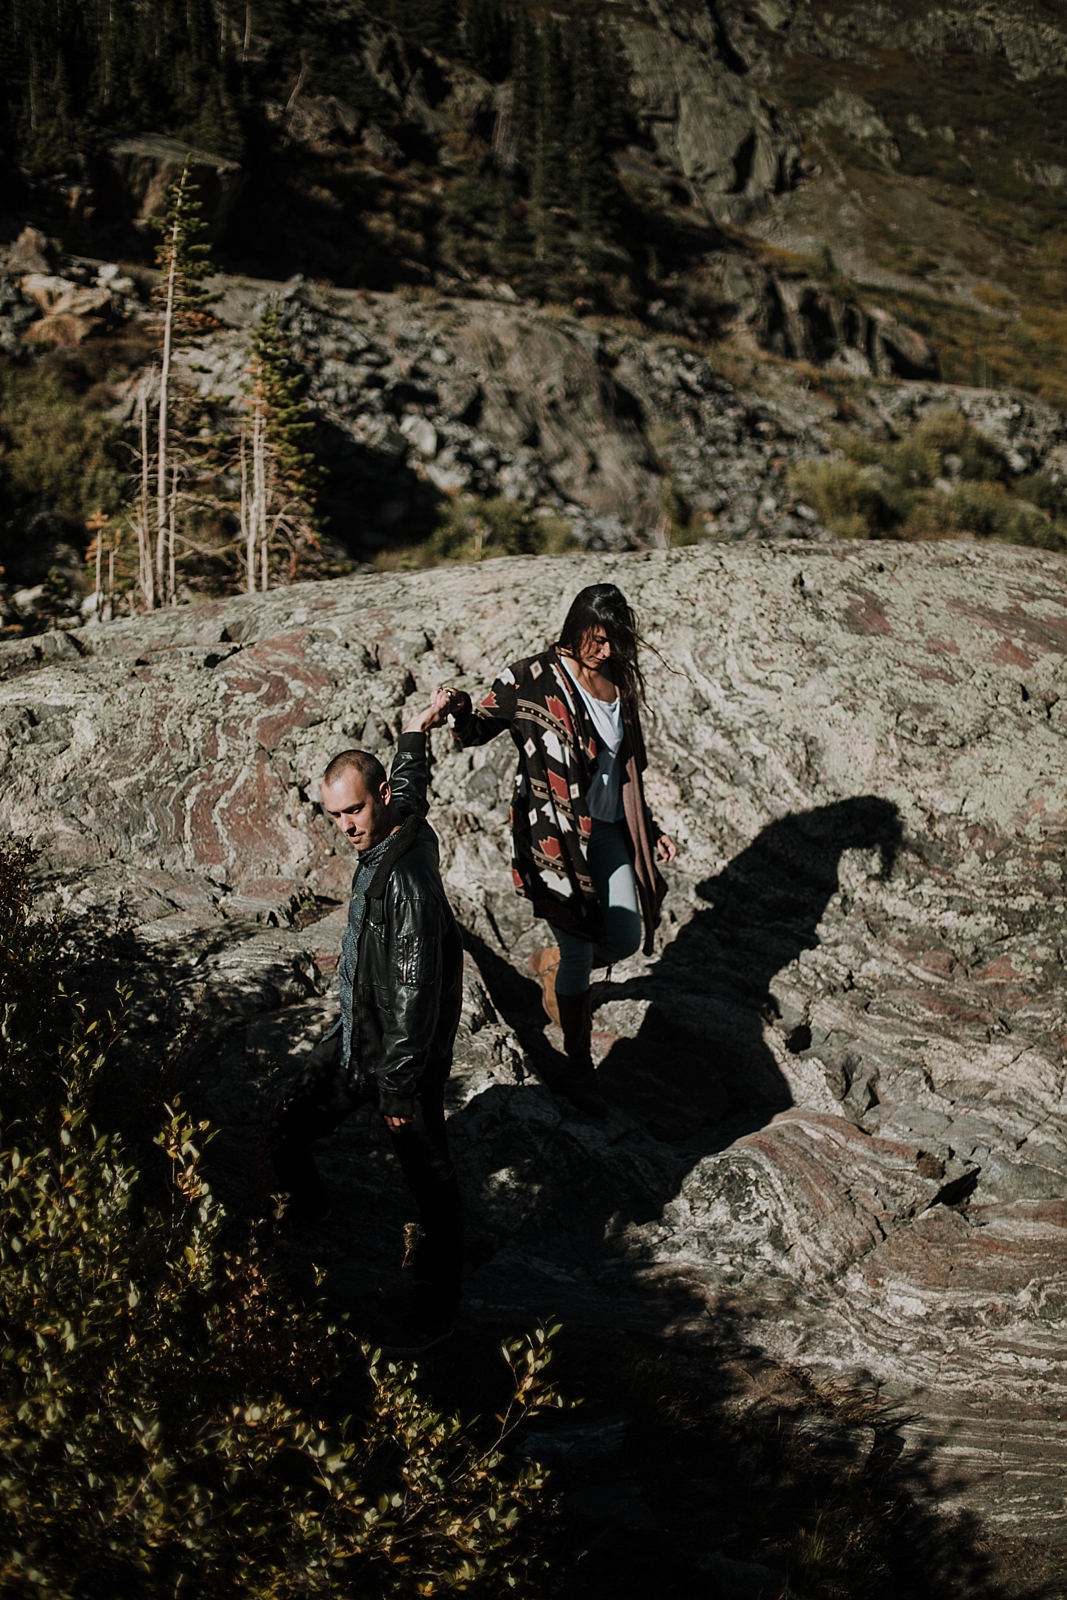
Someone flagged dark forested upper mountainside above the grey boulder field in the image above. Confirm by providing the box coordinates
[6,0,1067,384]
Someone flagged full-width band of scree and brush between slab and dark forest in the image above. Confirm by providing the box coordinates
[0,254,1067,588]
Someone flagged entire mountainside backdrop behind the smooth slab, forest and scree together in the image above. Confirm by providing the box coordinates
[0,0,1067,601]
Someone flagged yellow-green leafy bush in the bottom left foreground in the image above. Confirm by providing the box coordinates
[0,845,558,1600]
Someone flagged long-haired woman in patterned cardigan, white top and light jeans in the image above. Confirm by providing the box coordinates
[450,584,677,1117]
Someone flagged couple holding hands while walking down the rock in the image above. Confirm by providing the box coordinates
[272,584,677,1354]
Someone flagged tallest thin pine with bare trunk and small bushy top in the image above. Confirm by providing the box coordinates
[146,157,216,610]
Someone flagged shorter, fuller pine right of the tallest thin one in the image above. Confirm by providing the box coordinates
[240,304,322,594]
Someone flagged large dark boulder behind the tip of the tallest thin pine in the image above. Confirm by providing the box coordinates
[99,133,245,237]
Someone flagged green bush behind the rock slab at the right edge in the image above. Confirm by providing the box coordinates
[790,411,1067,550]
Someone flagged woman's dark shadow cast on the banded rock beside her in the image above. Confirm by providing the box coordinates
[466,795,904,1171]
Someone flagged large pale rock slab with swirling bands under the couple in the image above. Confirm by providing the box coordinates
[0,544,1067,1536]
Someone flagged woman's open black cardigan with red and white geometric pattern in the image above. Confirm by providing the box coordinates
[453,650,667,955]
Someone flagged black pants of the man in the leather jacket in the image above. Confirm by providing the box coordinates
[270,1034,462,1317]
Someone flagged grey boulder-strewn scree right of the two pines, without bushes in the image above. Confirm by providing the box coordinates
[177,270,1067,558]
